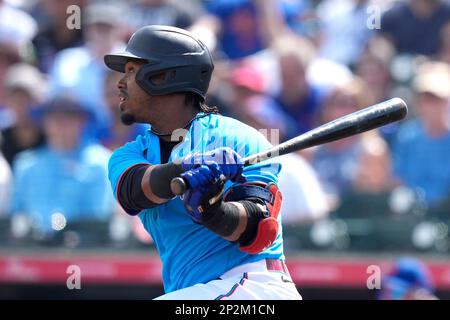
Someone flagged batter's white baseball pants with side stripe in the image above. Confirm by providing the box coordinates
[155,260,302,300]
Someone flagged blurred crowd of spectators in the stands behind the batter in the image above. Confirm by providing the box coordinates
[0,0,450,250]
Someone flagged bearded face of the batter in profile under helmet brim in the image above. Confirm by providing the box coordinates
[117,61,151,125]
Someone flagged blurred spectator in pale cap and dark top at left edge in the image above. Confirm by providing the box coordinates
[1,63,47,165]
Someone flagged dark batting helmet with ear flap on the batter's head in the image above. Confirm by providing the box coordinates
[104,25,214,100]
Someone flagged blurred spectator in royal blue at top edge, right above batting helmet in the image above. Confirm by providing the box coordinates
[192,0,310,60]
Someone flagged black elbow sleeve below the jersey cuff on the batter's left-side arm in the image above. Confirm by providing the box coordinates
[117,165,157,215]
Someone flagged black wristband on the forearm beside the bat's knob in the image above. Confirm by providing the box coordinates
[149,162,183,199]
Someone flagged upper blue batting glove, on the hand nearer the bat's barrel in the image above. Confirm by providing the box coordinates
[181,147,246,182]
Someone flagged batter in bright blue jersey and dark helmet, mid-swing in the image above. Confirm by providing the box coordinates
[105,26,301,300]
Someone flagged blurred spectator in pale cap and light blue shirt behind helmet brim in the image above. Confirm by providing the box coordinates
[49,3,123,139]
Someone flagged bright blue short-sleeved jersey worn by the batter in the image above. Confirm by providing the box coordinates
[109,113,284,293]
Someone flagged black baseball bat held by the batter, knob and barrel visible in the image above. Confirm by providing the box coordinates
[170,98,408,195]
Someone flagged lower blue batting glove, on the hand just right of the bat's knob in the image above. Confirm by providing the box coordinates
[181,163,224,224]
